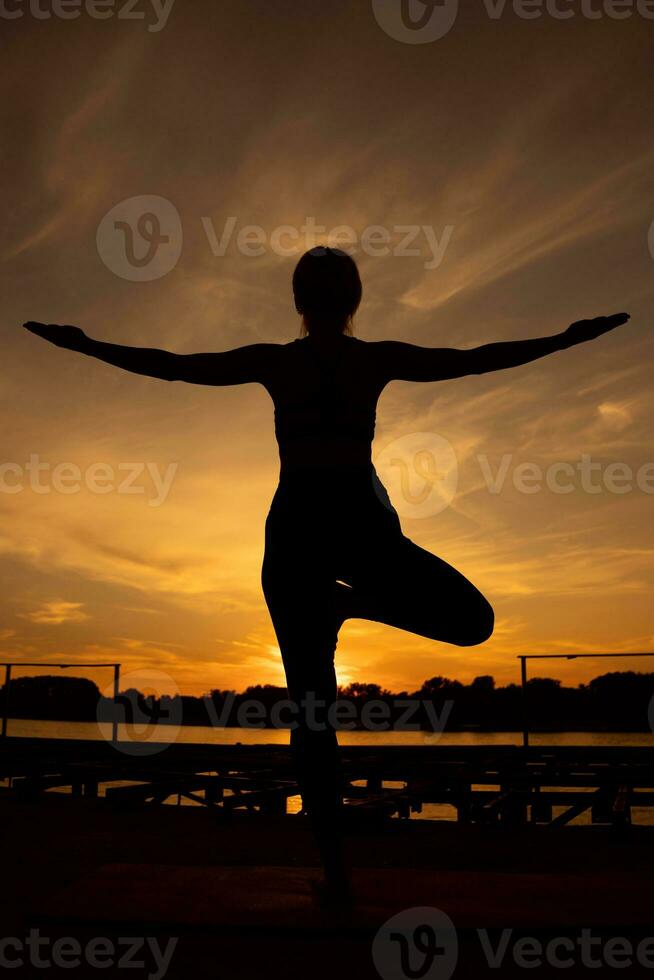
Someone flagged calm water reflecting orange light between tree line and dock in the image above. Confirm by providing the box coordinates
[8,719,654,825]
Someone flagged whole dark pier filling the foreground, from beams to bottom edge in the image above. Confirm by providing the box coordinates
[0,738,654,980]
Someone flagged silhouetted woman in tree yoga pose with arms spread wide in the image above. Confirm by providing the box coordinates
[25,247,629,895]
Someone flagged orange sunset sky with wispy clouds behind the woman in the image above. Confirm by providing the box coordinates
[0,0,654,694]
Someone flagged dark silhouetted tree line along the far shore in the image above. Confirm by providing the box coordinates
[0,671,654,732]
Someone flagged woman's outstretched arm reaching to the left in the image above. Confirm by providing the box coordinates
[24,321,279,385]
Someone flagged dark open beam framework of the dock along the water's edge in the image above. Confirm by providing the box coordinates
[0,737,654,828]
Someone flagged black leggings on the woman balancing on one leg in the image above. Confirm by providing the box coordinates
[261,468,494,828]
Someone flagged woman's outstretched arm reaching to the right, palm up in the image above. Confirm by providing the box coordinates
[375,313,629,381]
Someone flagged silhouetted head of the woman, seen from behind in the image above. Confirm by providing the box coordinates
[293,246,361,334]
